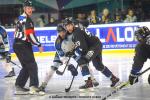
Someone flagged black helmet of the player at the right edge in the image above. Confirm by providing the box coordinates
[135,26,150,42]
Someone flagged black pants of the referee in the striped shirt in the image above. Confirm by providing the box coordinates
[13,40,39,87]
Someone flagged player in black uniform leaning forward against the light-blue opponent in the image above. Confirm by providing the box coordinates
[64,19,119,91]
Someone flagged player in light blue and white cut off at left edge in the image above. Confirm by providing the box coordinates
[0,26,15,77]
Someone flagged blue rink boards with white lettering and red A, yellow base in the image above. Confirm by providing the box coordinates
[7,22,150,56]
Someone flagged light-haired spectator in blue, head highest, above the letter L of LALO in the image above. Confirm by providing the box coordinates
[101,8,112,24]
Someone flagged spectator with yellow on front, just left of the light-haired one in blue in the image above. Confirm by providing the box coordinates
[88,10,100,24]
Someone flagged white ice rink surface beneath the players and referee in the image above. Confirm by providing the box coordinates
[0,54,150,100]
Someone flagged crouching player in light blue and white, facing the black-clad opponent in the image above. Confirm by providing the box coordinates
[39,24,99,92]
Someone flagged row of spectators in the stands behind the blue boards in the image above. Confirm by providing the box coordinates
[34,8,144,27]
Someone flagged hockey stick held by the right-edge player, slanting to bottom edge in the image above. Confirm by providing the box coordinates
[102,67,150,100]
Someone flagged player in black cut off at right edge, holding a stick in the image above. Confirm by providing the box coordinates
[129,26,150,85]
